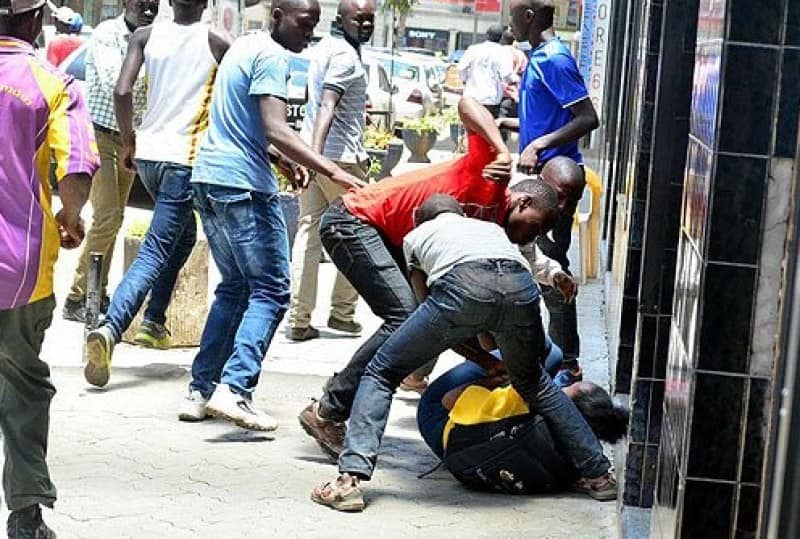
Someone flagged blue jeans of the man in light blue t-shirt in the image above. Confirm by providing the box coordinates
[189,183,289,398]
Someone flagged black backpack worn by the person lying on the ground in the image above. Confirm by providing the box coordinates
[444,414,578,494]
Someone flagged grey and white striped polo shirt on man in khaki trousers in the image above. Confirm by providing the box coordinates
[300,34,367,163]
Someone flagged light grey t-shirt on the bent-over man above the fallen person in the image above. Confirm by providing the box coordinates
[403,213,530,286]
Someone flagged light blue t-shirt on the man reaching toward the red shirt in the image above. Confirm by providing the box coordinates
[192,32,289,193]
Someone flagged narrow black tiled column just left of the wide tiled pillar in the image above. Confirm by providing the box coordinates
[620,0,698,507]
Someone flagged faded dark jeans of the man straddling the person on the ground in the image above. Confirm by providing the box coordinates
[339,260,609,479]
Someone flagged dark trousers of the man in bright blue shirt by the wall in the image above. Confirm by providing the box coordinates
[536,200,581,369]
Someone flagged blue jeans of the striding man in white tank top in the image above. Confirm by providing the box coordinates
[103,159,197,341]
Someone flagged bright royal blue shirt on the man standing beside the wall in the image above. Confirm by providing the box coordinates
[519,38,589,165]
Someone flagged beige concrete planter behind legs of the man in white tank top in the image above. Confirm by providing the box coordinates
[122,235,208,348]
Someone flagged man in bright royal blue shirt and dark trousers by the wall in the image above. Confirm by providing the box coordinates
[499,0,598,385]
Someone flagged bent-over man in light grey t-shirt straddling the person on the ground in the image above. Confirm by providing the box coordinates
[311,195,617,511]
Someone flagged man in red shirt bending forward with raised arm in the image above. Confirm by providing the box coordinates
[299,98,553,455]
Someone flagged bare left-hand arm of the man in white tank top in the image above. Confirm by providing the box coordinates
[114,26,152,171]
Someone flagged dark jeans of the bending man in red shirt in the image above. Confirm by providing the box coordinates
[319,202,418,421]
